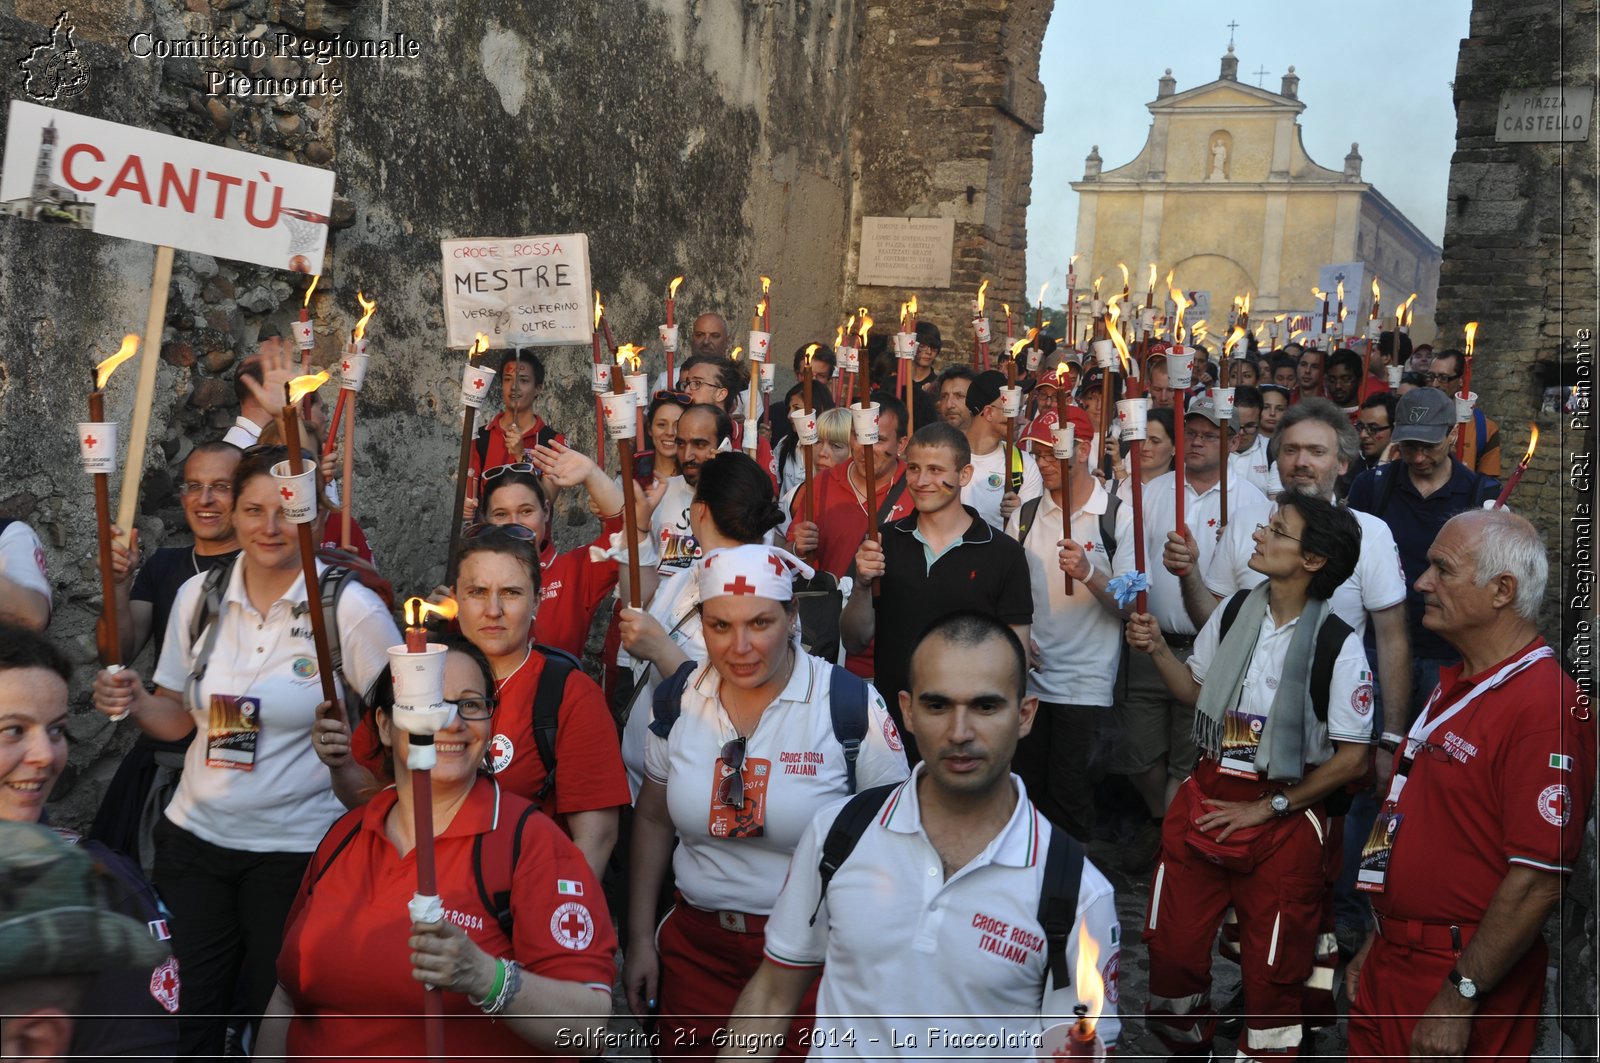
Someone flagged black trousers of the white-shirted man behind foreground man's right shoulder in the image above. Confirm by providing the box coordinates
[1011,701,1115,842]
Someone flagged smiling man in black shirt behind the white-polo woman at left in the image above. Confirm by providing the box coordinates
[90,442,243,876]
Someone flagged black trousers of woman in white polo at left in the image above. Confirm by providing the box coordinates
[155,816,310,1058]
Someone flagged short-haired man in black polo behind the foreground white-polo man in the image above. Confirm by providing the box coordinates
[840,421,1034,762]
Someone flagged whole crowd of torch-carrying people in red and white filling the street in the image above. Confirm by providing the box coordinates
[0,314,1595,1060]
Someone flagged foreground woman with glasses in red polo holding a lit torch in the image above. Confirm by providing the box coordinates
[256,639,616,1060]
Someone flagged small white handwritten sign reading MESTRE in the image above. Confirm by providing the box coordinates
[438,232,594,349]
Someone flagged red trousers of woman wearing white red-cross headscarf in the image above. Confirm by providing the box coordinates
[656,897,818,1058]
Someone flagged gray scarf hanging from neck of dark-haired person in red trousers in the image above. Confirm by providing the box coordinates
[1194,583,1328,783]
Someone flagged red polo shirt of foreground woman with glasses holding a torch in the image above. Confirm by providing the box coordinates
[278,778,616,1063]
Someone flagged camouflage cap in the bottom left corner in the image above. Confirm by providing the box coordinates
[0,823,168,981]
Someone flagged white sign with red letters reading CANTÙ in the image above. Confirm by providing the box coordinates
[0,99,333,274]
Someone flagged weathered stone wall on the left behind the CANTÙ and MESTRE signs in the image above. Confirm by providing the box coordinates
[0,0,902,824]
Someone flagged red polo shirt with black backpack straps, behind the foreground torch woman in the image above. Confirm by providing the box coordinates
[490,652,632,816]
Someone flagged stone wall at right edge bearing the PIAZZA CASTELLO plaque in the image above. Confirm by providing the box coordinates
[1435,0,1600,1058]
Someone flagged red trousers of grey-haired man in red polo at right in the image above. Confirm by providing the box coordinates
[1349,937,1546,1063]
